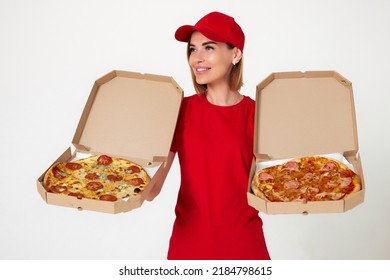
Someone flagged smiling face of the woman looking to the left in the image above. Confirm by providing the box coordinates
[188,31,238,85]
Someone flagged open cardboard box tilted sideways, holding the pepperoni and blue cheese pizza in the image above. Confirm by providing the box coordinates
[37,71,183,214]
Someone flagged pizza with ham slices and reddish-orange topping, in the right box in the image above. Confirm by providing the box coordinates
[251,156,361,203]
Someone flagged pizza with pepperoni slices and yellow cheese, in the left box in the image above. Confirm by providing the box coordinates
[43,155,150,201]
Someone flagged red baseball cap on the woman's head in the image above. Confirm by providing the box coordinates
[175,12,245,52]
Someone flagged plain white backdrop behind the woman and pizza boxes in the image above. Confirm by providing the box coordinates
[0,0,390,260]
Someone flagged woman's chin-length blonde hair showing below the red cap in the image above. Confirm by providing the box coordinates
[187,42,244,93]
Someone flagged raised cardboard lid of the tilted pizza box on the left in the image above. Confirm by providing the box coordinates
[72,71,183,165]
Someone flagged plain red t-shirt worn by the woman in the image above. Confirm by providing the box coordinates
[168,94,269,260]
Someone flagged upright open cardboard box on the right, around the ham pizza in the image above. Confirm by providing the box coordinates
[247,71,365,214]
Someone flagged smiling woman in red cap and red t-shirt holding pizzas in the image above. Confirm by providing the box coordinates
[168,12,269,260]
